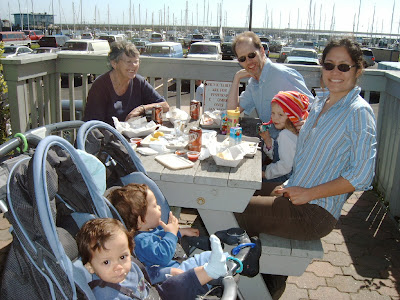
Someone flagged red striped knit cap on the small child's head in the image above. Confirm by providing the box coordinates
[271,91,309,124]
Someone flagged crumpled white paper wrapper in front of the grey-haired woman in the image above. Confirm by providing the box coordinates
[112,117,159,138]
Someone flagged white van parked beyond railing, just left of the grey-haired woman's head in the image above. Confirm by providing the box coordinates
[60,40,110,54]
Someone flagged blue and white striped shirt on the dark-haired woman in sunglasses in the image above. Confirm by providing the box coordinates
[287,87,376,219]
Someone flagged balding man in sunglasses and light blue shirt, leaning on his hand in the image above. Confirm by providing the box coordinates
[227,31,314,124]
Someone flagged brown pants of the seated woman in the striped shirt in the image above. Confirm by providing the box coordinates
[235,185,337,240]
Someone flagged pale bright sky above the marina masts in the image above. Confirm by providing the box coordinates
[0,0,400,34]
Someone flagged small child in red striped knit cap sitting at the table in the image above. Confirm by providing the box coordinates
[260,91,309,182]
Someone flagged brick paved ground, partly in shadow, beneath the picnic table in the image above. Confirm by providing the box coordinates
[0,191,400,300]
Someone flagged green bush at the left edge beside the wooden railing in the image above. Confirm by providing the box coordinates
[0,43,11,144]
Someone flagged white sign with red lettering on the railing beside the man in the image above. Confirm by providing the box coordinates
[204,81,232,111]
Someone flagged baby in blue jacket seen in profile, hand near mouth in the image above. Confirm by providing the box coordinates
[108,183,229,284]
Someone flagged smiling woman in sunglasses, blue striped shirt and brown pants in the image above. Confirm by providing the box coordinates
[236,39,376,240]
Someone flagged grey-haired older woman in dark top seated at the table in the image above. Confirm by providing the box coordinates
[83,42,169,125]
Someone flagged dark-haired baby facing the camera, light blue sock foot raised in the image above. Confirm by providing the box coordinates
[76,218,227,300]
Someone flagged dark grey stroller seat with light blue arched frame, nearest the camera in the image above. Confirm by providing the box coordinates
[1,120,253,299]
